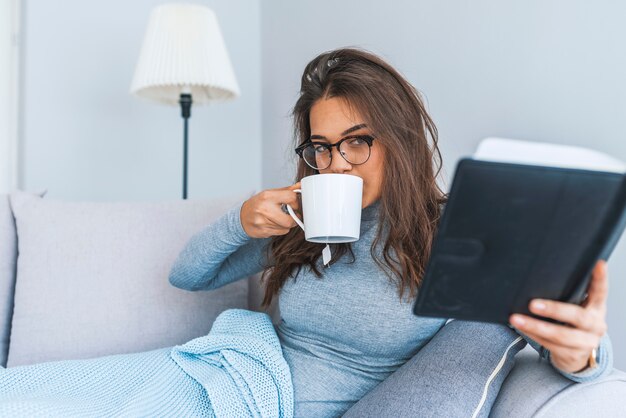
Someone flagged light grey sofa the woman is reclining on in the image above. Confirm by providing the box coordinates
[0,191,626,417]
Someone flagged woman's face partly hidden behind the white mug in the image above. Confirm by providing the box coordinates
[309,97,383,208]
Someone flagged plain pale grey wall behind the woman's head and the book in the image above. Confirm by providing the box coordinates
[261,0,626,370]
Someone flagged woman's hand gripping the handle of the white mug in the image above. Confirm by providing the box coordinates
[240,182,300,238]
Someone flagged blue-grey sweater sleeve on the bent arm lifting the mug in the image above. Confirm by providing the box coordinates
[169,202,271,291]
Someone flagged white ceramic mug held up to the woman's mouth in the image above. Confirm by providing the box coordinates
[285,173,363,243]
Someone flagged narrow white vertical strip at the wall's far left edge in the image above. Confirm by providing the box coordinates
[0,0,20,193]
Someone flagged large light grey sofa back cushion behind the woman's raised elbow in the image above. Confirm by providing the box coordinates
[7,191,249,367]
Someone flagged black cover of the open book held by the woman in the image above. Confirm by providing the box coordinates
[413,158,626,324]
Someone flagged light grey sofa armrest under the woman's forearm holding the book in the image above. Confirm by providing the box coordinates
[490,346,626,418]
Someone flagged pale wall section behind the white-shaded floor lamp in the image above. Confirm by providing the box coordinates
[21,0,261,200]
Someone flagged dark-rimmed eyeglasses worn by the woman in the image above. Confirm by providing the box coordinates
[295,135,376,170]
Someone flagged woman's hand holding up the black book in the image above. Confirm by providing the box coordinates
[509,260,608,373]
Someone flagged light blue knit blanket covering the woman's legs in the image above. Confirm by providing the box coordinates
[0,309,293,417]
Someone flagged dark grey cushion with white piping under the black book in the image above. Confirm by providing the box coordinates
[344,320,526,418]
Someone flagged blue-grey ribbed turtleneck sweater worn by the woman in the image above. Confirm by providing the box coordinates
[169,200,610,417]
